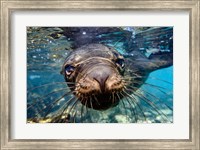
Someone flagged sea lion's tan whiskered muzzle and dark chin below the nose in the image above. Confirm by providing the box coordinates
[75,78,125,110]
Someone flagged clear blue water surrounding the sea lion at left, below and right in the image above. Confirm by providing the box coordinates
[27,28,173,123]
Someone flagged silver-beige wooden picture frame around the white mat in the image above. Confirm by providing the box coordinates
[0,0,200,150]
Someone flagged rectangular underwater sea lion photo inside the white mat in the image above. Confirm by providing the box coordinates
[27,27,173,123]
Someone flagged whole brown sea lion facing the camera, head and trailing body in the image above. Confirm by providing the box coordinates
[61,44,172,110]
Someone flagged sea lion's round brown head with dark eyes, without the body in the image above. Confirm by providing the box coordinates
[62,44,125,110]
